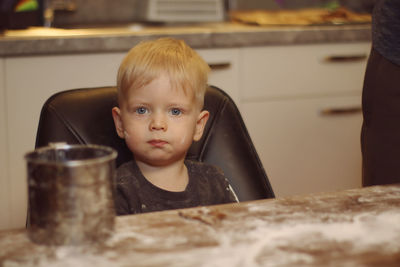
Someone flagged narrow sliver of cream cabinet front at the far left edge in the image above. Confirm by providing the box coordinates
[0,59,10,230]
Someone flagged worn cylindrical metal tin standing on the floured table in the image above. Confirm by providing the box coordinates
[25,143,117,245]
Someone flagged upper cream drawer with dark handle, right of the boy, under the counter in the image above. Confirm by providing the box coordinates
[241,43,370,100]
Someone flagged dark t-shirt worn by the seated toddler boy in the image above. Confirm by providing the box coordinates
[115,160,237,215]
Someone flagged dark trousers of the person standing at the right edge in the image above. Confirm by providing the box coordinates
[361,49,400,186]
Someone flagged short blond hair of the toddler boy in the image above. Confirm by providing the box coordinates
[117,38,210,107]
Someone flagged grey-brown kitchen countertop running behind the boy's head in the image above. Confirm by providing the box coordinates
[0,22,371,57]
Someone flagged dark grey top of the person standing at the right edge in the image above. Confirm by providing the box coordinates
[372,0,400,66]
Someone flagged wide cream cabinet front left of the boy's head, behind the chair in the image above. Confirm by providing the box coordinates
[5,53,124,230]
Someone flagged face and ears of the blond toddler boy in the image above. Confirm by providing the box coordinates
[113,75,209,166]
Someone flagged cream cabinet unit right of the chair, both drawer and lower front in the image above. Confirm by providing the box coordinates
[240,43,370,197]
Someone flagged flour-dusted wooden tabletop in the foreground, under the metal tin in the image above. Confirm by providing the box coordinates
[0,185,400,267]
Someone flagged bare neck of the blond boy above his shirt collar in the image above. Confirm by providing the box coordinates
[136,160,189,192]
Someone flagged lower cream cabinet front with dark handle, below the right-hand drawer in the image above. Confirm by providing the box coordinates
[242,96,362,197]
